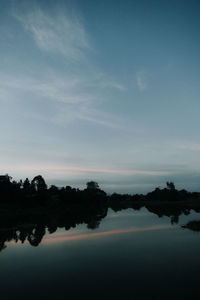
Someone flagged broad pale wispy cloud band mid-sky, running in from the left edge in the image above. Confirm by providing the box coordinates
[0,72,127,128]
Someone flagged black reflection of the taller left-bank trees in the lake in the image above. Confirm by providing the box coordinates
[0,205,108,251]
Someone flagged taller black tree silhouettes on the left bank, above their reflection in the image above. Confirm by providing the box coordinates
[0,175,106,206]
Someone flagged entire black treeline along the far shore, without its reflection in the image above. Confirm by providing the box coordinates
[0,175,200,206]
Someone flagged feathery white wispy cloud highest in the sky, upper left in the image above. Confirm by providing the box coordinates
[14,7,90,61]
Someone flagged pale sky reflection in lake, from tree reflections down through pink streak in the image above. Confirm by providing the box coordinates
[6,208,200,247]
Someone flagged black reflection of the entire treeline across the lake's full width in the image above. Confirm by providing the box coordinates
[0,198,200,251]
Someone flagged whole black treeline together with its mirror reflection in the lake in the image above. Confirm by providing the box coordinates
[0,175,200,251]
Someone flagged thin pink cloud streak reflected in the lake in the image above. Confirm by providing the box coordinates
[42,225,171,244]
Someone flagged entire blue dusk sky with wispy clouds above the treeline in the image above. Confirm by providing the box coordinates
[0,0,200,193]
